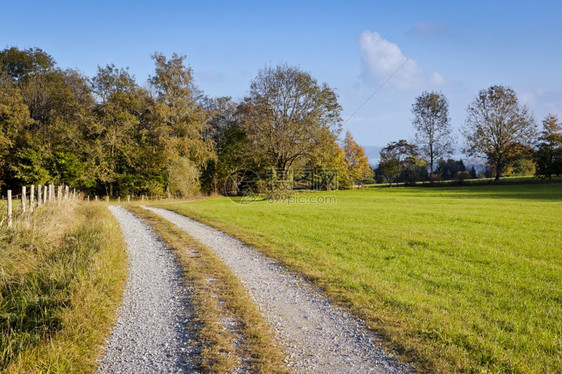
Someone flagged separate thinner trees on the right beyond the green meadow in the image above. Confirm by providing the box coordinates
[374,86,562,184]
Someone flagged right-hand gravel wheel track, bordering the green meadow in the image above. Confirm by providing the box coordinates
[146,207,411,373]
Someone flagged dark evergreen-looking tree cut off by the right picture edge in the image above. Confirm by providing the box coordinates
[535,114,562,181]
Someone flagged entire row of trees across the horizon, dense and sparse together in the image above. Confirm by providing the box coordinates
[0,47,561,197]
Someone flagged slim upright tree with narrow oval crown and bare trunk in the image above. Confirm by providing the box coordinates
[412,92,453,183]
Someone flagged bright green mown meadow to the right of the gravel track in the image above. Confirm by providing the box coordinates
[152,184,562,373]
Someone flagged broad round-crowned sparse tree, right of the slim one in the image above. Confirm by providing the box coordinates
[463,86,536,181]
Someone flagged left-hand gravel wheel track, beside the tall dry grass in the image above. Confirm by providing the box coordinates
[98,206,198,374]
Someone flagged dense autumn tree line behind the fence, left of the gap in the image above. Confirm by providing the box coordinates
[0,47,371,196]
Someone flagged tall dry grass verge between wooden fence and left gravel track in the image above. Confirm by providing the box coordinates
[0,202,127,373]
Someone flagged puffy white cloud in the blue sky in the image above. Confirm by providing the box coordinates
[359,30,446,90]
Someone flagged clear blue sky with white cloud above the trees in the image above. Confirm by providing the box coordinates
[0,0,562,155]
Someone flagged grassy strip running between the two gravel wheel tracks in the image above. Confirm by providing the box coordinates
[126,205,287,373]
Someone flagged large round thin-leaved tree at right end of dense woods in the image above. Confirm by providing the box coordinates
[238,65,341,178]
